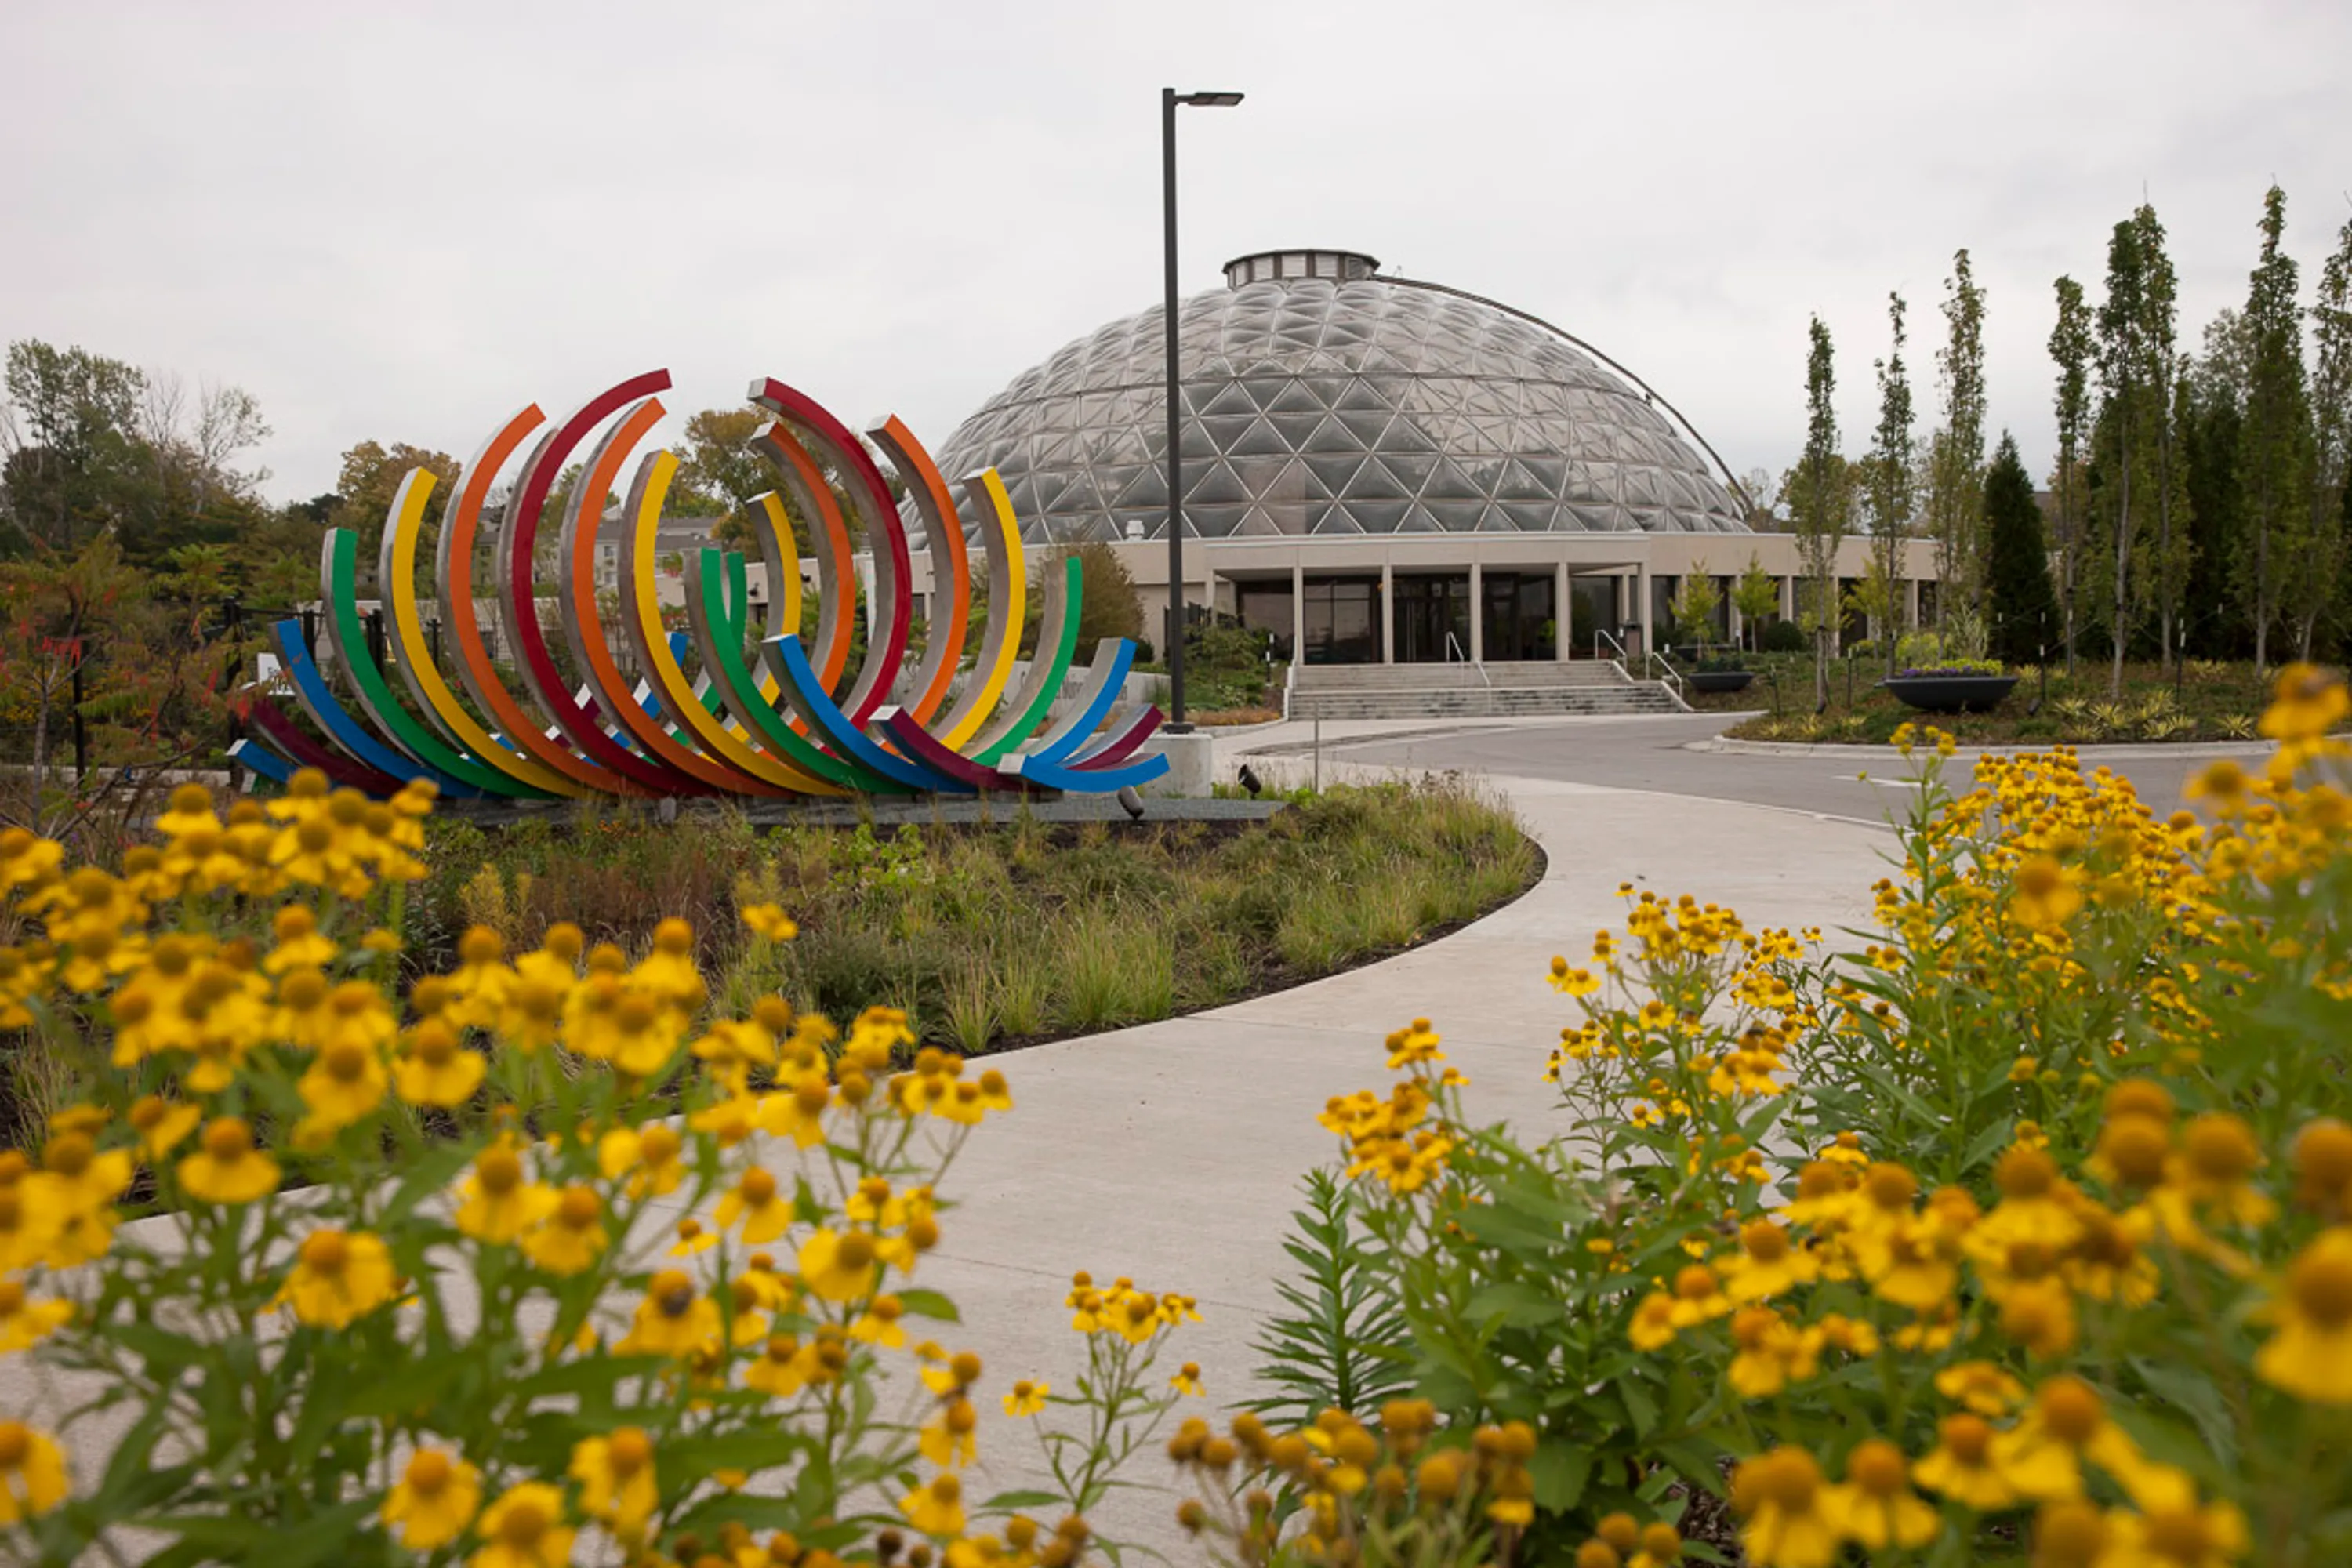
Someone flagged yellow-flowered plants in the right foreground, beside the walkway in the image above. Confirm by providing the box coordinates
[1261,668,2352,1568]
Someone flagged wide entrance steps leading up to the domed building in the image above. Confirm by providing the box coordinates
[1287,661,1689,720]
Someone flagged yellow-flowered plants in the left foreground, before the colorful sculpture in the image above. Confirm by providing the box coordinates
[0,774,1200,1568]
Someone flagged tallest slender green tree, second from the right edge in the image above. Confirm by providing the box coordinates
[2239,186,2310,673]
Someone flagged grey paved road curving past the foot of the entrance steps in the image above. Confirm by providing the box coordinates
[1324,713,2267,822]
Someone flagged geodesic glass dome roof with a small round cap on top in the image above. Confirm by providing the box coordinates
[938,249,1748,543]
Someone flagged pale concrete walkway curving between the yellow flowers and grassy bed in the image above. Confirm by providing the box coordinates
[856,724,1893,1561]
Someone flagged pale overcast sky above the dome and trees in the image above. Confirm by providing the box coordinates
[0,0,2352,499]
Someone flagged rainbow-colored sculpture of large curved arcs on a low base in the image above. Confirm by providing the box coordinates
[230,372,1167,801]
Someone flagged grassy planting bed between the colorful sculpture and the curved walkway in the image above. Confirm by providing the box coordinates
[405,781,1541,1053]
